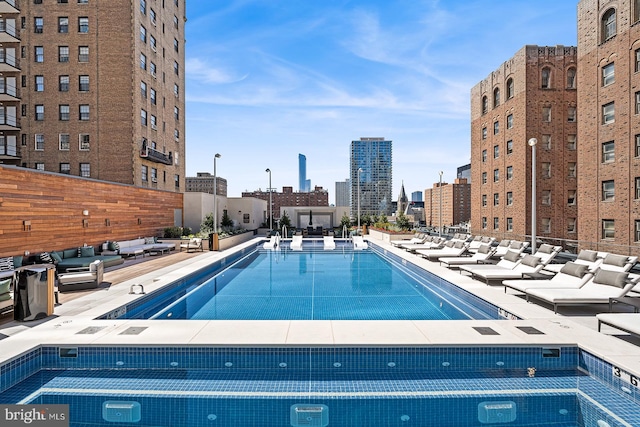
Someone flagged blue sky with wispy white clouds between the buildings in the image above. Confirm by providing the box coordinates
[186,0,578,203]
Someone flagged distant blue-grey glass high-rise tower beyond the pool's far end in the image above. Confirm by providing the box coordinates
[350,138,393,218]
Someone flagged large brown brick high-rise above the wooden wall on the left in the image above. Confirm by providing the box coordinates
[15,0,186,192]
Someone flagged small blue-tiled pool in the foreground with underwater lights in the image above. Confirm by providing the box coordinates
[0,346,640,427]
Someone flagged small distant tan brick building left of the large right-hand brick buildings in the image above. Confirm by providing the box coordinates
[424,178,471,231]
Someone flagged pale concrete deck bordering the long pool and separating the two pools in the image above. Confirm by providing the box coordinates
[0,238,640,382]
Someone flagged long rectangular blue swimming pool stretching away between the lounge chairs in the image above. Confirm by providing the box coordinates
[103,246,502,320]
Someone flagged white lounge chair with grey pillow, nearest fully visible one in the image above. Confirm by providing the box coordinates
[527,269,640,313]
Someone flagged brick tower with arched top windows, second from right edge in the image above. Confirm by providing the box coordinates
[471,46,585,244]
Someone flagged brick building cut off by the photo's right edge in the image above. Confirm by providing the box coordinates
[578,0,640,253]
